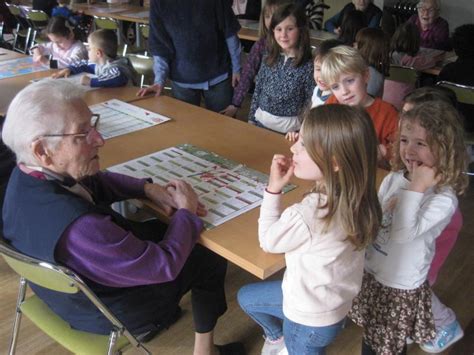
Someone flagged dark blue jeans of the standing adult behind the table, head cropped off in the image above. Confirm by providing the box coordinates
[171,77,234,112]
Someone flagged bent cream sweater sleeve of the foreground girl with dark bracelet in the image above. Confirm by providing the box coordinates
[258,192,311,253]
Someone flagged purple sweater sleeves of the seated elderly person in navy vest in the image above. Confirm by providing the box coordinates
[55,173,203,287]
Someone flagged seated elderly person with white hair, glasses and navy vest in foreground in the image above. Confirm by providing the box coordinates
[2,80,240,354]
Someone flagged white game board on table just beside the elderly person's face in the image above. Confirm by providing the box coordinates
[89,99,170,139]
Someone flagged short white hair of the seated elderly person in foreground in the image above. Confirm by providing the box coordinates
[2,79,83,165]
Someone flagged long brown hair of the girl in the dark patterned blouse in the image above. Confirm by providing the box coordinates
[266,3,312,67]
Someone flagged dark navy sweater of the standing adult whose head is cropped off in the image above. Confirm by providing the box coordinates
[149,0,240,84]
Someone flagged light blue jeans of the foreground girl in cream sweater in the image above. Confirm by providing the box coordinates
[237,281,344,355]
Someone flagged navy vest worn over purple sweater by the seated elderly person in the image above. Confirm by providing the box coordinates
[3,168,170,334]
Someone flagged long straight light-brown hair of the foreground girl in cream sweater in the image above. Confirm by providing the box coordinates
[301,104,382,249]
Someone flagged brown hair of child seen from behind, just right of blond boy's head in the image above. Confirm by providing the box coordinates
[356,27,390,76]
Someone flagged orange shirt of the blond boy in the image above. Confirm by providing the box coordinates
[326,95,398,152]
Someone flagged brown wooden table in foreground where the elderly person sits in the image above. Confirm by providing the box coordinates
[100,96,388,279]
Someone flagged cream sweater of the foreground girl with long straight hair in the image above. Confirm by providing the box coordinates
[258,192,364,327]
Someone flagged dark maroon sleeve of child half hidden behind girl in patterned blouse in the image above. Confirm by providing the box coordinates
[232,37,267,107]
